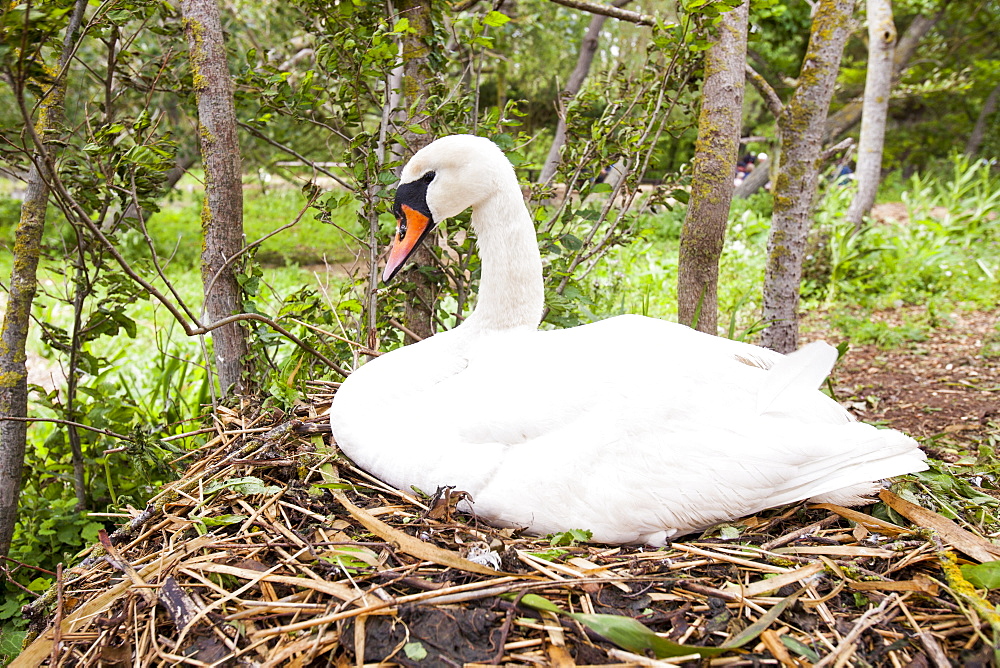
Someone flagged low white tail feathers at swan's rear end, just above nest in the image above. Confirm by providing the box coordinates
[796,423,927,506]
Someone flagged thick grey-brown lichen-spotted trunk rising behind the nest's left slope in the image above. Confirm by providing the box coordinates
[181,0,251,395]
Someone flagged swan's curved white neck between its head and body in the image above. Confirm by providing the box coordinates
[465,184,545,330]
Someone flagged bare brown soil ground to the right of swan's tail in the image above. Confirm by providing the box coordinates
[803,309,1000,462]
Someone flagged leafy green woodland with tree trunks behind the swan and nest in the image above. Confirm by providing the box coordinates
[0,0,1000,656]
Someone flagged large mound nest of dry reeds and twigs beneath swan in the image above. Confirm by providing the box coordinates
[12,383,1000,667]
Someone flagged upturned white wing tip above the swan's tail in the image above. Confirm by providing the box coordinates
[757,341,837,414]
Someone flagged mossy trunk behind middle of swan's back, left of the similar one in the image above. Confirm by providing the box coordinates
[677,0,748,334]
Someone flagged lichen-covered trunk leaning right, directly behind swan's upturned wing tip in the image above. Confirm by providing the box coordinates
[761,0,854,353]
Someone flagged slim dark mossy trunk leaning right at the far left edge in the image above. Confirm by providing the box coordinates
[0,0,87,557]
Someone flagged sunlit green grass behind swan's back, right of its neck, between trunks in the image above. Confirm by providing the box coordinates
[584,157,1000,347]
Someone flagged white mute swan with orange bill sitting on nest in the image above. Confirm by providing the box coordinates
[330,135,927,545]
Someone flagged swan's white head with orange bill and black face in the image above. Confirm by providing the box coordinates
[382,135,517,281]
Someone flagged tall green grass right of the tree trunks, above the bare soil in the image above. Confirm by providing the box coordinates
[803,156,1000,308]
